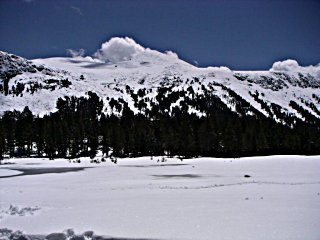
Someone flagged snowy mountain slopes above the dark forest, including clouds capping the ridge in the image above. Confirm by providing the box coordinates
[0,38,320,123]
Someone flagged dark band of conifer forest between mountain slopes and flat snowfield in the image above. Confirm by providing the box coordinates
[0,87,320,159]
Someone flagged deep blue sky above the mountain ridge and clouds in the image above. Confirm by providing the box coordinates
[0,0,320,70]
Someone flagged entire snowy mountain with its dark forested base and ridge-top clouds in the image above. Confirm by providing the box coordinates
[0,38,320,158]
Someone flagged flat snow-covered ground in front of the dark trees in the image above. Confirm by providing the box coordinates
[0,156,320,240]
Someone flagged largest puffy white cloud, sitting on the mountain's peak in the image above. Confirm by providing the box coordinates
[94,37,146,63]
